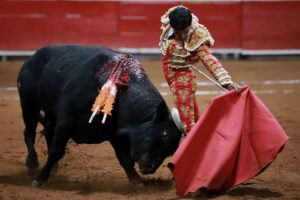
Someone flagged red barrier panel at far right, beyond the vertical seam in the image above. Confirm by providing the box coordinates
[241,1,300,50]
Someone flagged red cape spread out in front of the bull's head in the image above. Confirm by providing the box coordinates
[170,87,288,196]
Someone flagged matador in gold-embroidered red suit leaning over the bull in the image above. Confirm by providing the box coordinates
[159,6,239,133]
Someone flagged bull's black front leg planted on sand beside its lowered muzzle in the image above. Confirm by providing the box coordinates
[111,142,144,188]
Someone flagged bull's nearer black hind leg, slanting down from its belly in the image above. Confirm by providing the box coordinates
[32,124,71,187]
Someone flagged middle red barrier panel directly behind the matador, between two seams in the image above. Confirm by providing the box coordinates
[119,2,242,48]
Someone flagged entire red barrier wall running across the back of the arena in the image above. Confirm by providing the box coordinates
[0,0,300,54]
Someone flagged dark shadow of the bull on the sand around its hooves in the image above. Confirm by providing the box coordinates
[0,171,174,195]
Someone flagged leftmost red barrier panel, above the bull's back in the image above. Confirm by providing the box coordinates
[0,1,118,50]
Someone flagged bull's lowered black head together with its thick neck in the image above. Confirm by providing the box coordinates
[110,60,183,174]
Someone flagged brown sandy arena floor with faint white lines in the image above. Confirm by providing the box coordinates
[0,58,300,200]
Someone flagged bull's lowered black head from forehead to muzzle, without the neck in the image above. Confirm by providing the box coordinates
[131,101,183,174]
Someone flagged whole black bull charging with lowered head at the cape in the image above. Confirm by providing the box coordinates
[18,46,181,186]
